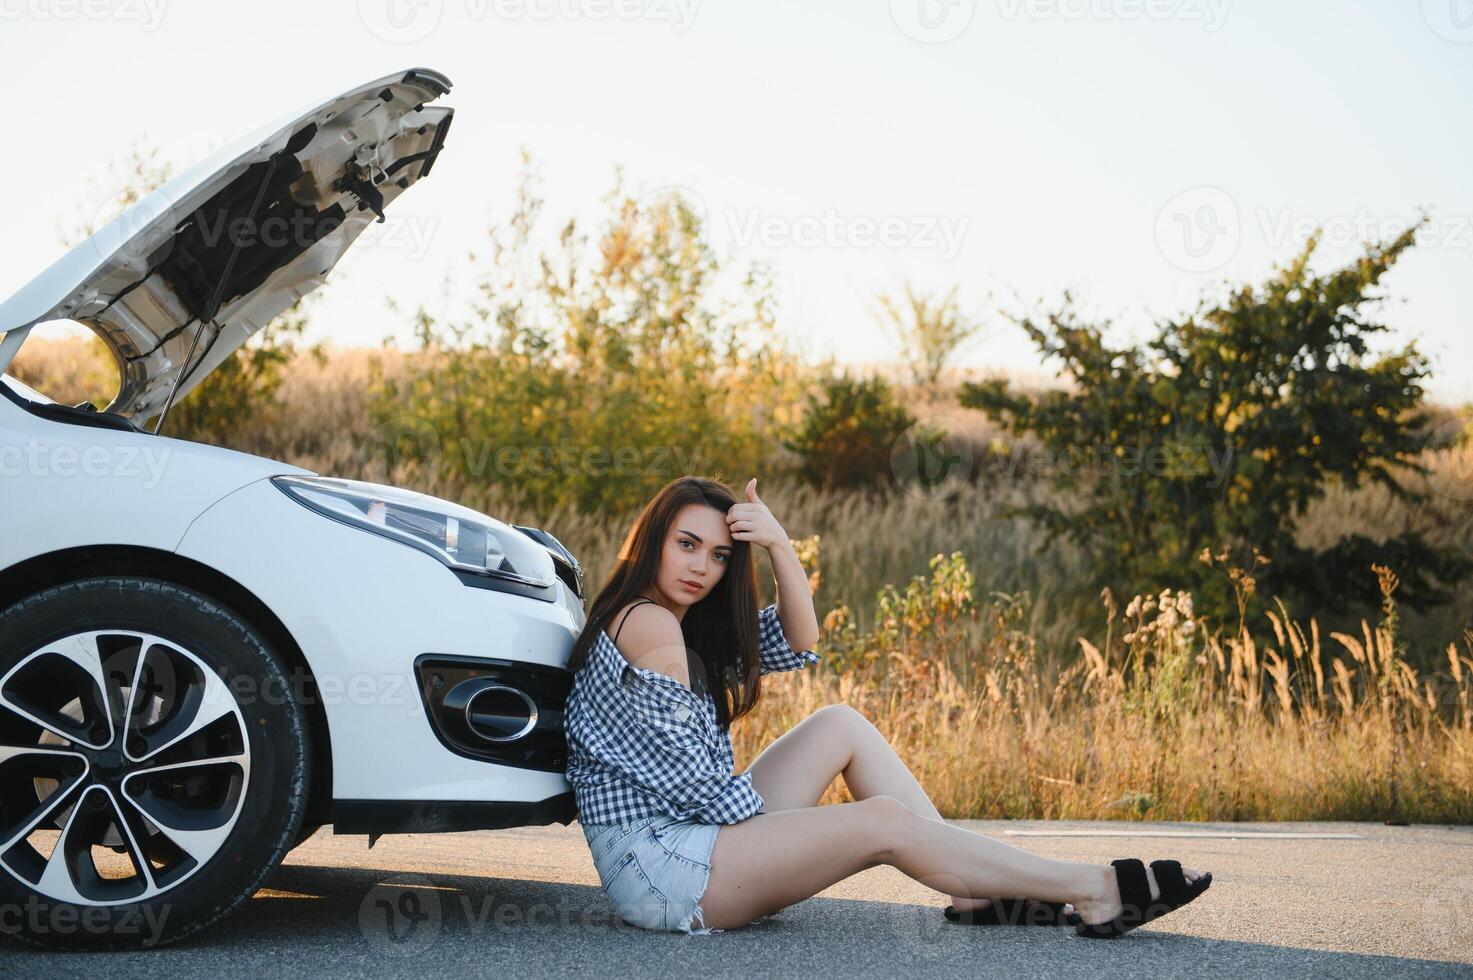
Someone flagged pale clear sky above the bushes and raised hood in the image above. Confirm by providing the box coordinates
[0,0,1473,401]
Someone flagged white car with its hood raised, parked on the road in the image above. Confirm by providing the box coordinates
[0,69,585,948]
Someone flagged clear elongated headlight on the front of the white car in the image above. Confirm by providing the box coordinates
[271,476,557,588]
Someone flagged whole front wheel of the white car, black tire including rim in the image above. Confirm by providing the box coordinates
[0,576,311,949]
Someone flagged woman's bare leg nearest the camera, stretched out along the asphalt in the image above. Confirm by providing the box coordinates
[701,796,1118,928]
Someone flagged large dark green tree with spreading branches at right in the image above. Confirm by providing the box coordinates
[960,228,1470,612]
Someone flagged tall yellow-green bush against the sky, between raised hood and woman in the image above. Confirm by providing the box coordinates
[374,159,800,513]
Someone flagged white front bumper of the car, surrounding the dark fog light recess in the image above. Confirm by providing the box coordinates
[177,480,583,813]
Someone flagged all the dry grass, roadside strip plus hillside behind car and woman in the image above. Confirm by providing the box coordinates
[15,339,1473,822]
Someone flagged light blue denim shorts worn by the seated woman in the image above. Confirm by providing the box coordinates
[583,816,722,936]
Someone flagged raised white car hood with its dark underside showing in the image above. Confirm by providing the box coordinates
[0,68,454,421]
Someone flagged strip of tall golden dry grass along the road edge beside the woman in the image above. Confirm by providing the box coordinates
[734,556,1473,824]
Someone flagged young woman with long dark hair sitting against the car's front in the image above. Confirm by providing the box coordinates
[566,476,1212,937]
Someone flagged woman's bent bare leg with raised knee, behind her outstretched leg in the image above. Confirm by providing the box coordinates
[748,704,1001,911]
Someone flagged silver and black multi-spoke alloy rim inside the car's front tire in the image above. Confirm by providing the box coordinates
[0,629,250,905]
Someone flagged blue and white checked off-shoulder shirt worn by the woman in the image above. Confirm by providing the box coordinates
[564,604,819,824]
